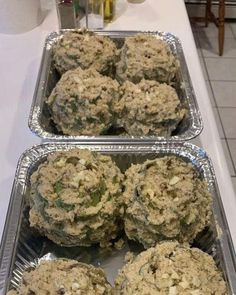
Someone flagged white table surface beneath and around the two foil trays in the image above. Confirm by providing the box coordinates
[0,0,236,254]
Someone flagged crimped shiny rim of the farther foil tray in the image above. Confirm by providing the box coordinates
[28,29,203,144]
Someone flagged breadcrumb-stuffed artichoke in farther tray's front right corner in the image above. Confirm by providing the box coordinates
[114,80,186,137]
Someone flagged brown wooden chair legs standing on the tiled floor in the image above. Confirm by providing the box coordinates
[205,0,225,56]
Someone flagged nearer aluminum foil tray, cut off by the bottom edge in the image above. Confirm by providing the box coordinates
[0,143,236,294]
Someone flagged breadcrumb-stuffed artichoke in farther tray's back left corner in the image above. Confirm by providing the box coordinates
[53,30,117,75]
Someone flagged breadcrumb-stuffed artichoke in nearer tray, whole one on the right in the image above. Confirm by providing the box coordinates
[123,156,212,248]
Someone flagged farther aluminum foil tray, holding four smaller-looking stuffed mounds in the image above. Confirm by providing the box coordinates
[29,30,203,144]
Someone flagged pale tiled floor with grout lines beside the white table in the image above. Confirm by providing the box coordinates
[192,23,236,192]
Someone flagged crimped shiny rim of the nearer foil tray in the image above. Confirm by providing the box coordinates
[0,142,236,294]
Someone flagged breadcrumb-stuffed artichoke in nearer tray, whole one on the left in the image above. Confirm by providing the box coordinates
[30,149,123,247]
